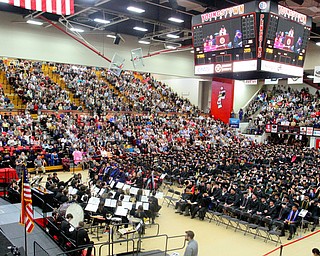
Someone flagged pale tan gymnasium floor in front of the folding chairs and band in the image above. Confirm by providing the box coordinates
[43,171,320,256]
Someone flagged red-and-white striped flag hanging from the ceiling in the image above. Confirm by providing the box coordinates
[9,0,74,15]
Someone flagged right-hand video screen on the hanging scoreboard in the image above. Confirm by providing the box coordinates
[273,18,304,53]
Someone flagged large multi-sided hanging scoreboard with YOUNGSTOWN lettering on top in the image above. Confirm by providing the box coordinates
[192,1,312,80]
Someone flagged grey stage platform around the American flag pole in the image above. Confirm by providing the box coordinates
[0,198,63,256]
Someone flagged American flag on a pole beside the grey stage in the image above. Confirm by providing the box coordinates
[20,168,34,233]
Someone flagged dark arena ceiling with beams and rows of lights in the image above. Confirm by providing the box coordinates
[0,0,320,45]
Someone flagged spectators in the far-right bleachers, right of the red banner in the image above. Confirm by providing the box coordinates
[244,85,320,134]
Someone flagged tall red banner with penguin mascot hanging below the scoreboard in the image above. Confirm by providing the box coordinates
[211,78,234,123]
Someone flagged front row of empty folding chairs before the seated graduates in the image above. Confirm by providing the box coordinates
[206,209,284,245]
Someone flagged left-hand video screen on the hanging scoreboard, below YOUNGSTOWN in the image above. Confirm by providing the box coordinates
[203,17,242,52]
